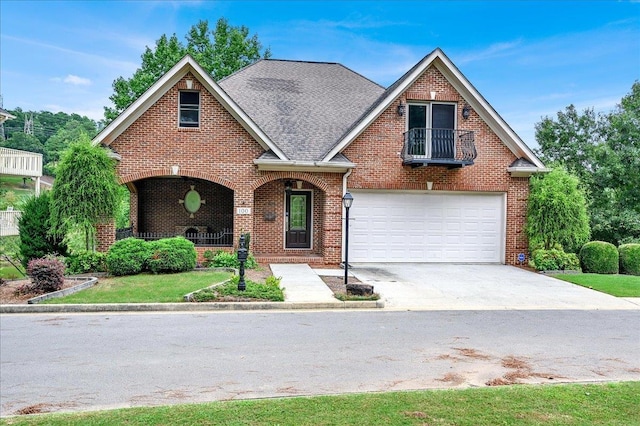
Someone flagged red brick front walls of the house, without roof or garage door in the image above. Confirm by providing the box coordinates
[98,62,528,265]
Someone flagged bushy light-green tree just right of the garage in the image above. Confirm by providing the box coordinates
[526,168,590,252]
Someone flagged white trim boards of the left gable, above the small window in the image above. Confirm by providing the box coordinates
[93,55,287,160]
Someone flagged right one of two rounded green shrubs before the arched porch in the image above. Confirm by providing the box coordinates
[147,237,198,274]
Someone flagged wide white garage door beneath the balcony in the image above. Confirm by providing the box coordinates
[349,191,505,263]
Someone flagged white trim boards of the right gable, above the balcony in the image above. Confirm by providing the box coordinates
[323,49,544,170]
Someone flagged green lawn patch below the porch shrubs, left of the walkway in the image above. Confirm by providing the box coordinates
[43,271,232,304]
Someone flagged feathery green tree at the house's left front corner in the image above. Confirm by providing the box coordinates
[51,134,119,250]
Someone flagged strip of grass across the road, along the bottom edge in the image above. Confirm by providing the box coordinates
[0,382,640,426]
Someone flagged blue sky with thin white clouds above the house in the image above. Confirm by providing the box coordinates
[0,0,640,146]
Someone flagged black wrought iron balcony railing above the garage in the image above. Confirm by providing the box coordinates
[402,128,478,167]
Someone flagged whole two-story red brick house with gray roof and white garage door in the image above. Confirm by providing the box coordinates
[94,49,544,264]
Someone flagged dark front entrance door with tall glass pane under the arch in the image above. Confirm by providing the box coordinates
[285,191,311,248]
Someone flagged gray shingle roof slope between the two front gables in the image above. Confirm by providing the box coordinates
[219,59,385,161]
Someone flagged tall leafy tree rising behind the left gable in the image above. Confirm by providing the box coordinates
[104,18,271,123]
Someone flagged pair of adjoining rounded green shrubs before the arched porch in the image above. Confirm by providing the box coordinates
[106,237,197,275]
